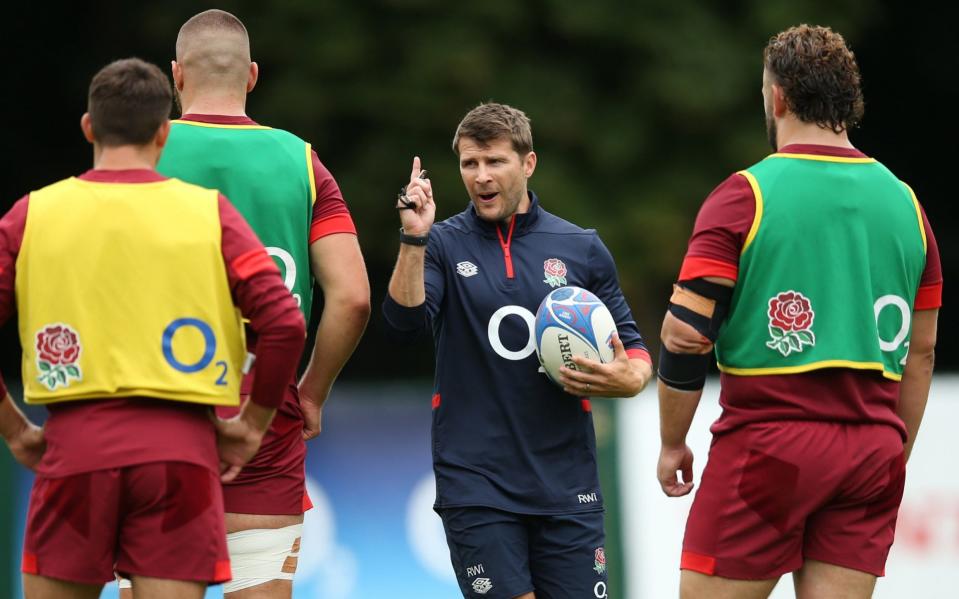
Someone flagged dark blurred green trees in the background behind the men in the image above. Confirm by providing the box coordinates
[2,0,959,380]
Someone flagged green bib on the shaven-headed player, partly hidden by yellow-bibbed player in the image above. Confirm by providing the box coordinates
[157,120,316,322]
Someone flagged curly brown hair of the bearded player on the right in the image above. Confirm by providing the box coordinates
[763,24,863,133]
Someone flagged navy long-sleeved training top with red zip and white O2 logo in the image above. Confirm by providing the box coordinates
[383,193,646,514]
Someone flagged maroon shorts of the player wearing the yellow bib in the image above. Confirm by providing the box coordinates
[22,462,230,584]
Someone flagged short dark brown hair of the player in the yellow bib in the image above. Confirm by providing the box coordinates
[87,58,173,146]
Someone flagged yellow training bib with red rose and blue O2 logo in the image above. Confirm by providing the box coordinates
[16,178,246,406]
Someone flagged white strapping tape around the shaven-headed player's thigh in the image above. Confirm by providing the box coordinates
[223,524,303,593]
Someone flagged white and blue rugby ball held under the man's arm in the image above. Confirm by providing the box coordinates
[534,287,616,385]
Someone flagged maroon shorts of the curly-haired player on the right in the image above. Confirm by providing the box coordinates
[680,421,905,580]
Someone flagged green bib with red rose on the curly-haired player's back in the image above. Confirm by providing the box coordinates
[716,154,926,381]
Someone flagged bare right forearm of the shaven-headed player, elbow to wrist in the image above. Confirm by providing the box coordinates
[300,298,370,405]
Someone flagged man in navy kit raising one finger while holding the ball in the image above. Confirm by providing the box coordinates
[383,103,652,599]
